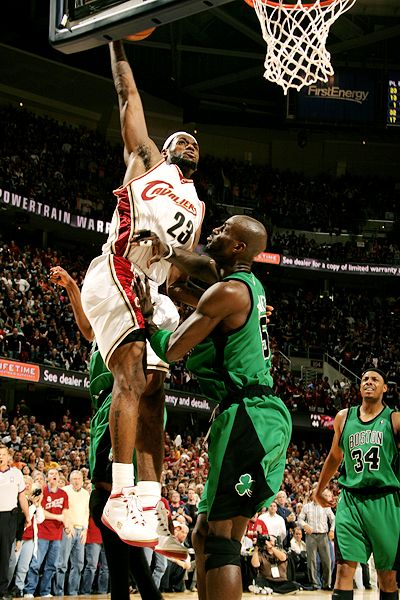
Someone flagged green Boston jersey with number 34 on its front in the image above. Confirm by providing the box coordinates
[339,406,400,493]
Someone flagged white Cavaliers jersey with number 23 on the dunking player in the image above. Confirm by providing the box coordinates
[102,160,204,285]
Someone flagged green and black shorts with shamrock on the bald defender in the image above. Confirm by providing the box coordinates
[199,396,292,521]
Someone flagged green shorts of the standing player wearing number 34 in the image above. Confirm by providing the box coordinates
[335,489,400,571]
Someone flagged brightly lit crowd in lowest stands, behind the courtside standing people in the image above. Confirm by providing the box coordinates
[0,401,338,597]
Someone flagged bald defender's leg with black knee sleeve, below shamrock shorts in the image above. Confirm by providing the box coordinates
[204,517,249,600]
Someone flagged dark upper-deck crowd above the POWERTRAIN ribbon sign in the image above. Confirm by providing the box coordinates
[0,106,399,237]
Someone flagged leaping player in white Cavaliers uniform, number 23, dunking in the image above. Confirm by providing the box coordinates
[82,42,204,546]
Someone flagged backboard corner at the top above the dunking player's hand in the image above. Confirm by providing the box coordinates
[49,0,232,54]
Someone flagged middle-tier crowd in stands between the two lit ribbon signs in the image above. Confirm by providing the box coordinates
[0,232,400,414]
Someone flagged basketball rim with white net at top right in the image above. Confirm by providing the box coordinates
[245,0,356,95]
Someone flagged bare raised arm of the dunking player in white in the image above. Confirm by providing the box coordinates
[109,41,161,177]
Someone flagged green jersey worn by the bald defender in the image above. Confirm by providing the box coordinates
[186,271,273,402]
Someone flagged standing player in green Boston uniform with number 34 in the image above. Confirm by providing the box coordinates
[316,367,400,600]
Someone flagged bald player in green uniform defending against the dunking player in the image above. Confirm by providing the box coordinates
[136,215,291,600]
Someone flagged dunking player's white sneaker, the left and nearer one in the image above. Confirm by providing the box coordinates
[101,486,158,548]
